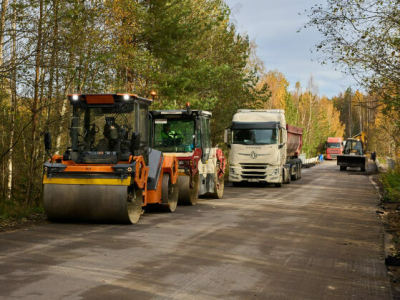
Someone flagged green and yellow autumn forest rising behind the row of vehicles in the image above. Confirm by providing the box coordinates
[0,0,398,208]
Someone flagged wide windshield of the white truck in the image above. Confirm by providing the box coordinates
[232,128,278,145]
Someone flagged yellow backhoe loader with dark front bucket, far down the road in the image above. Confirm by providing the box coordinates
[337,131,368,172]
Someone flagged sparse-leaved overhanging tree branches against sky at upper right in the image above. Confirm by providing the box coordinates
[305,0,400,119]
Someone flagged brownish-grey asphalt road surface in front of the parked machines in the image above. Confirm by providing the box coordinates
[0,162,392,300]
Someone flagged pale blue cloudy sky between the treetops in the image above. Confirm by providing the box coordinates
[225,0,356,98]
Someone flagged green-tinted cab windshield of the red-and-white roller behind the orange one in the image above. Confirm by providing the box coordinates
[154,119,195,152]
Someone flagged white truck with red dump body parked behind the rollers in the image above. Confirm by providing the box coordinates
[224,109,303,187]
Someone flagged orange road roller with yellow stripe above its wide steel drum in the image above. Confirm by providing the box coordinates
[43,94,179,224]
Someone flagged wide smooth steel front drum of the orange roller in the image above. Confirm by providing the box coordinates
[43,184,142,223]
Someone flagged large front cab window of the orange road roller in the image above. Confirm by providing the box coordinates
[71,104,135,152]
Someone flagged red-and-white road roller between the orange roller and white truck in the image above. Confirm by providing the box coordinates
[150,104,226,205]
